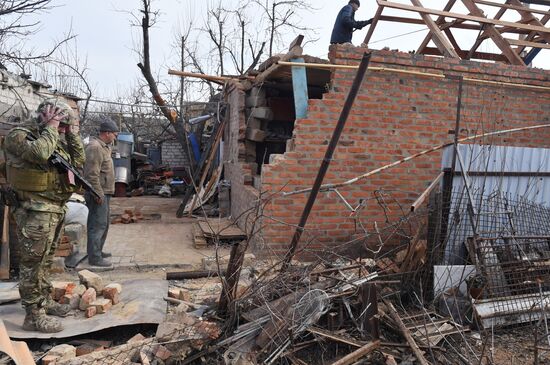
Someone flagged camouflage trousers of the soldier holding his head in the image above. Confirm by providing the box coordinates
[14,207,64,307]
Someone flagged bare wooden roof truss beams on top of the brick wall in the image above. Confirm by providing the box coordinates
[364,0,550,65]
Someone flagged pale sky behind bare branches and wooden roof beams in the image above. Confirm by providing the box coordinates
[21,0,550,99]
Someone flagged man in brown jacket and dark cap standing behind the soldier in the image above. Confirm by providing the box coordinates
[84,118,118,267]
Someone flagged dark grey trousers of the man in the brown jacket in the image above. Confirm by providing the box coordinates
[85,194,111,263]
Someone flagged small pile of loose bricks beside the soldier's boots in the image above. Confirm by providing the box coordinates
[52,270,122,318]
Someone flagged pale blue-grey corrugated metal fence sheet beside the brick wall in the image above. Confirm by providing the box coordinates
[442,145,550,264]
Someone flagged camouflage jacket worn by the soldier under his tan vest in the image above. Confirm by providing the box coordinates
[3,119,85,213]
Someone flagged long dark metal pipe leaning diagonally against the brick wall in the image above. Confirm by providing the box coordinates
[281,53,371,271]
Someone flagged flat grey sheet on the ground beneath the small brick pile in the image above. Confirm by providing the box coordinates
[0,279,168,339]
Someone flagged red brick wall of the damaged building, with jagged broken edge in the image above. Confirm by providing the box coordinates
[248,46,550,254]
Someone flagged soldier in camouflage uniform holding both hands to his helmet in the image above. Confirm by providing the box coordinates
[3,99,85,333]
